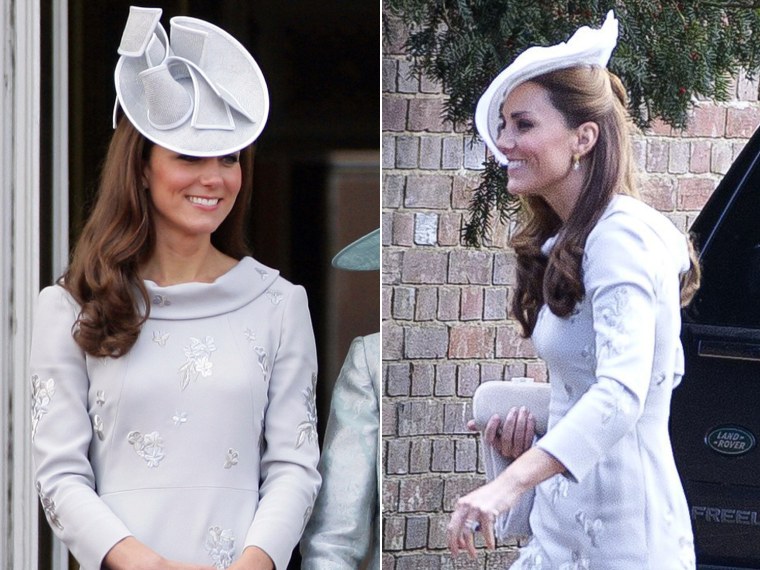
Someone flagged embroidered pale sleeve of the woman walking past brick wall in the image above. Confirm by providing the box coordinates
[538,215,660,480]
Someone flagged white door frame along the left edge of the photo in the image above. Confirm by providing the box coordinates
[0,0,40,570]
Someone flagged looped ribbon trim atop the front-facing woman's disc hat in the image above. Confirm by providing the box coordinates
[113,7,254,131]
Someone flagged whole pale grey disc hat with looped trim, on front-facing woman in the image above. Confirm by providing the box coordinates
[113,6,269,156]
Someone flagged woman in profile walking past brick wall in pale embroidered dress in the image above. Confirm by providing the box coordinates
[448,13,698,570]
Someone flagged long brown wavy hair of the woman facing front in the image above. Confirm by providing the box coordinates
[58,117,253,357]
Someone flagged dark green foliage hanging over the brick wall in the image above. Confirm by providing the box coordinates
[385,0,760,244]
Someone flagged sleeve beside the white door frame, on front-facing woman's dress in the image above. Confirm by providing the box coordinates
[30,286,130,569]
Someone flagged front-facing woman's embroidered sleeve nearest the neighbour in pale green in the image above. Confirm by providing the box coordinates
[245,287,320,570]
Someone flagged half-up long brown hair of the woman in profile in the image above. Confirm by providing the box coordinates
[511,66,700,337]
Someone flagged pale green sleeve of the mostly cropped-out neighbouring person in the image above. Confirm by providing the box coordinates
[301,335,380,570]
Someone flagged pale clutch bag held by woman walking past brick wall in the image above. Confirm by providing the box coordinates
[472,380,551,436]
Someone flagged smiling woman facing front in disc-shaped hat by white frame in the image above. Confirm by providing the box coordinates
[30,7,320,570]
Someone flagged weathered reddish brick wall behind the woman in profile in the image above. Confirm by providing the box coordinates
[382,14,760,570]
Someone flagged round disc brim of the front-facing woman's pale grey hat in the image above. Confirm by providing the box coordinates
[114,12,269,156]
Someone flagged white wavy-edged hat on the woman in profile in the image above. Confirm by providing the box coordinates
[475,10,618,165]
